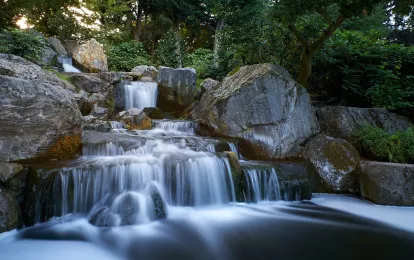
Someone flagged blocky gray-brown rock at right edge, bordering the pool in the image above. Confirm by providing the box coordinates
[360,161,414,206]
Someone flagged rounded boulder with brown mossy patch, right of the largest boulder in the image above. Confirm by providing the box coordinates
[303,134,360,193]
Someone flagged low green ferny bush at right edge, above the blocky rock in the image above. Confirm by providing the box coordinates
[351,125,414,163]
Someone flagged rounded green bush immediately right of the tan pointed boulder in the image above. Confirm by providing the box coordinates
[107,41,150,71]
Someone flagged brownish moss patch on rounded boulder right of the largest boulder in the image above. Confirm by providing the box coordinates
[323,142,355,171]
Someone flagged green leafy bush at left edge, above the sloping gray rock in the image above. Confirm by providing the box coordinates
[0,29,47,62]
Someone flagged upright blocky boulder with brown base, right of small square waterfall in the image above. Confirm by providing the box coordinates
[157,67,197,112]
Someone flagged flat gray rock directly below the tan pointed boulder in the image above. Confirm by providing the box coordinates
[70,73,110,93]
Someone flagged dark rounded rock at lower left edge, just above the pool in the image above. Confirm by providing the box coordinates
[0,188,22,233]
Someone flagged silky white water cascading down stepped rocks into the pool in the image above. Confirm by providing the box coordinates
[0,82,414,260]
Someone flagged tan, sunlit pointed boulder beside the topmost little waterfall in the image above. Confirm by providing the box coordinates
[73,39,108,72]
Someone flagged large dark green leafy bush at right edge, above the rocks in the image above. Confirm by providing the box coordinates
[314,30,414,110]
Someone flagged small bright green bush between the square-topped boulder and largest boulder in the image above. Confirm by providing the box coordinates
[184,49,213,78]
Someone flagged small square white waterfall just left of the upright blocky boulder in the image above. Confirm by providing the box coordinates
[125,81,158,110]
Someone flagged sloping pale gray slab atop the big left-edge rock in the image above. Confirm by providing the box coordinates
[0,54,75,91]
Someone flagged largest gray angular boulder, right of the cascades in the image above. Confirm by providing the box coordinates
[192,64,319,159]
